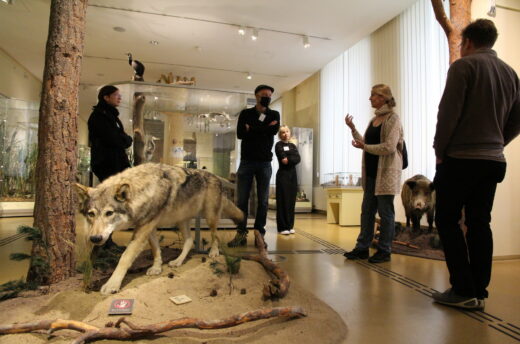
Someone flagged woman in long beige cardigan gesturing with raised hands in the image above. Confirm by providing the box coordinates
[344,84,403,263]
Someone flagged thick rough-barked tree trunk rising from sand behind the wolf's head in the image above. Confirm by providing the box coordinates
[27,0,87,283]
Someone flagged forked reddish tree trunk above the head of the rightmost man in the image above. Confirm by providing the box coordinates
[432,0,471,64]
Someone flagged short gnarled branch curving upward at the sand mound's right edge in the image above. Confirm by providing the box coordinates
[243,230,291,300]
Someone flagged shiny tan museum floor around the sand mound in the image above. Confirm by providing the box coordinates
[0,213,520,344]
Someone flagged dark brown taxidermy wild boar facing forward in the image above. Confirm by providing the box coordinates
[401,174,435,232]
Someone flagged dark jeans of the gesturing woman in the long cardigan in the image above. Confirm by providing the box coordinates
[356,177,395,253]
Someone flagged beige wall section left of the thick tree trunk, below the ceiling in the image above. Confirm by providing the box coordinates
[0,48,42,102]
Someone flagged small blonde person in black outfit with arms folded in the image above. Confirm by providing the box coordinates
[274,125,300,235]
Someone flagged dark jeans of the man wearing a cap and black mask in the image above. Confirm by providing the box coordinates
[237,160,272,234]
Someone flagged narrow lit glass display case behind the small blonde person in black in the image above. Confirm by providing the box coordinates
[269,127,313,213]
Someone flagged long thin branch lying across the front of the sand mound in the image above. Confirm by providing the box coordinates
[0,306,307,344]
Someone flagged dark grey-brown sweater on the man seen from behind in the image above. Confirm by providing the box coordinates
[433,48,520,161]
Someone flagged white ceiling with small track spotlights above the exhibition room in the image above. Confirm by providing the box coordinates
[0,0,416,95]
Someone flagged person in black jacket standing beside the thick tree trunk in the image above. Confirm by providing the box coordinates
[88,85,132,182]
